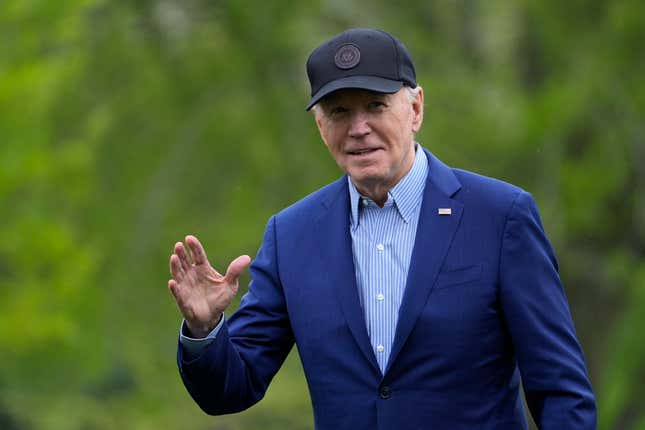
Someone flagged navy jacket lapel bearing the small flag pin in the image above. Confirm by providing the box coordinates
[385,151,463,374]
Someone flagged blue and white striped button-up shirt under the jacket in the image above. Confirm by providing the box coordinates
[349,145,428,373]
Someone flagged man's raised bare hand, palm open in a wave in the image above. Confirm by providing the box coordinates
[168,236,251,338]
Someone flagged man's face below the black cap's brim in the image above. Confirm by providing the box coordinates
[314,88,423,197]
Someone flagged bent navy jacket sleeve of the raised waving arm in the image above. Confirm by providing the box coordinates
[177,218,294,415]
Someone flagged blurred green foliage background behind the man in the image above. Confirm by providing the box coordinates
[0,0,645,430]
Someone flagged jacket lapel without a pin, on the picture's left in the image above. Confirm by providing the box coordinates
[317,176,381,373]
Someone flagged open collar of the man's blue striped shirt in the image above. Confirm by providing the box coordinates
[347,144,428,228]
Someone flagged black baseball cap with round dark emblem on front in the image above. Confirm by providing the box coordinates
[305,28,417,110]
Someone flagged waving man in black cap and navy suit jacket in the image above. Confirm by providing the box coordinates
[169,29,596,430]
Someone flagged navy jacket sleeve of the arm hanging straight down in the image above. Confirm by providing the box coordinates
[500,192,596,430]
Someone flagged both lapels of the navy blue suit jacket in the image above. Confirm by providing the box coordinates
[315,151,463,374]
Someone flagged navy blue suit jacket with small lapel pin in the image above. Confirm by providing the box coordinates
[178,152,596,430]
